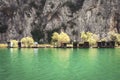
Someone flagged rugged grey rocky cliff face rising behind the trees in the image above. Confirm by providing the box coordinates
[0,0,120,42]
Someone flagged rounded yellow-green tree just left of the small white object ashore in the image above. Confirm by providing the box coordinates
[21,37,34,47]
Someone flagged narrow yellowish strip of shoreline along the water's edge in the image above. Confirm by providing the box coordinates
[0,44,120,49]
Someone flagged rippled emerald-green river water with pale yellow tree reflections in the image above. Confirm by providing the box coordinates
[0,48,120,80]
